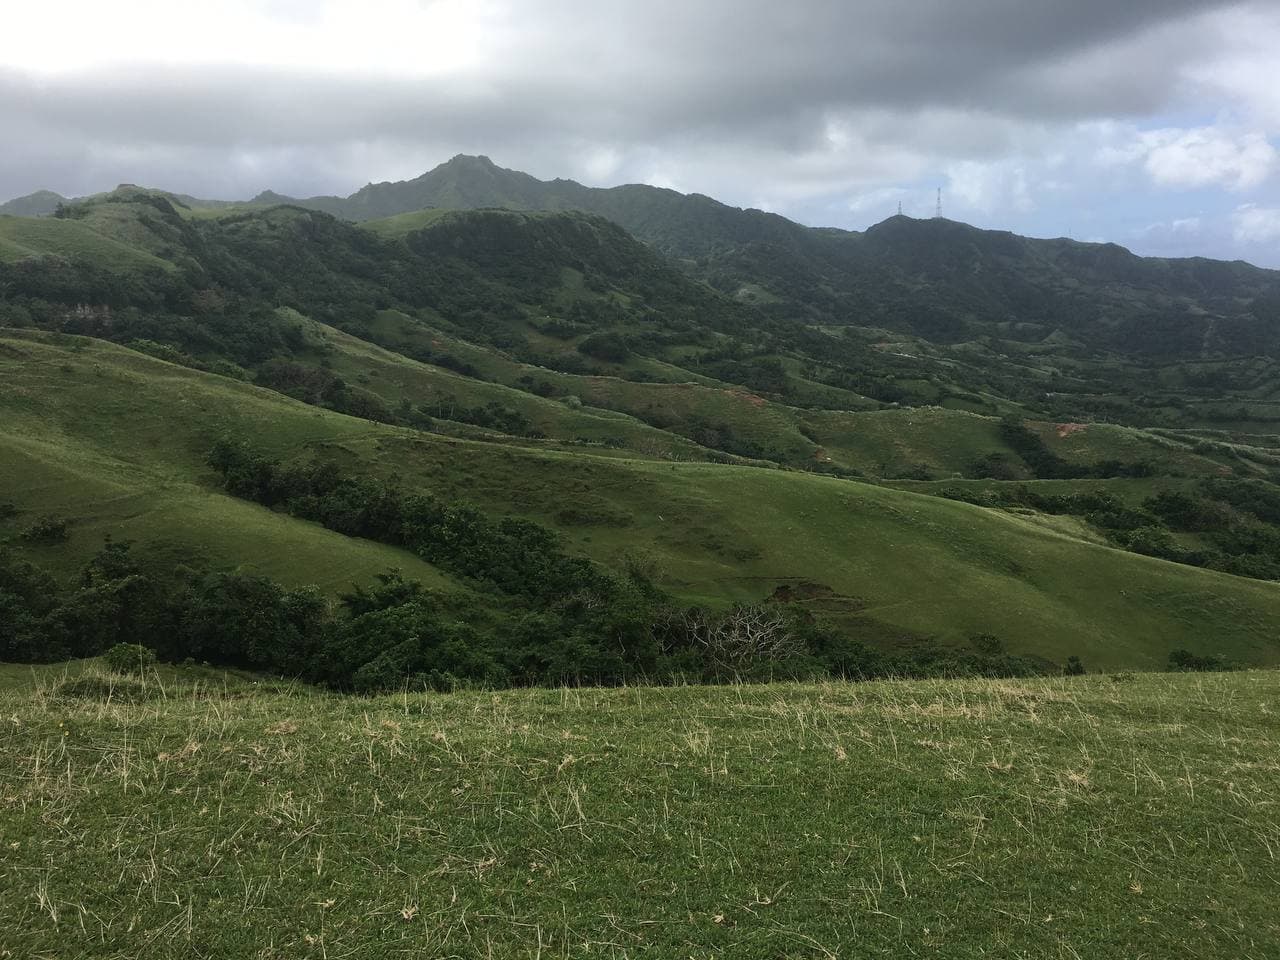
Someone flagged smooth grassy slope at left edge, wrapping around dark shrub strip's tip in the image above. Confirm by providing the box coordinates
[0,337,458,590]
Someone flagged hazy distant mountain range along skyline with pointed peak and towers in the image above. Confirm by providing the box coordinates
[0,155,1280,357]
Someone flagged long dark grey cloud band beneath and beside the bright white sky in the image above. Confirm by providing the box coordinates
[0,0,1228,146]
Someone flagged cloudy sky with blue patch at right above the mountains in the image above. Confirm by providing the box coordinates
[0,0,1280,268]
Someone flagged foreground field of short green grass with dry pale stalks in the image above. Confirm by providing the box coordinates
[0,666,1280,959]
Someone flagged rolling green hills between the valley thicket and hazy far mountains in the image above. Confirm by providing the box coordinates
[0,188,1280,668]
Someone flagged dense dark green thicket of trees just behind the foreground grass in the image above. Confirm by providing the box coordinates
[0,535,1059,692]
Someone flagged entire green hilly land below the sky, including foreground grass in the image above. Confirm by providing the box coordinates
[0,146,1280,960]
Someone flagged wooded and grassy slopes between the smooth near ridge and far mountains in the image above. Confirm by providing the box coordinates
[0,188,1280,599]
